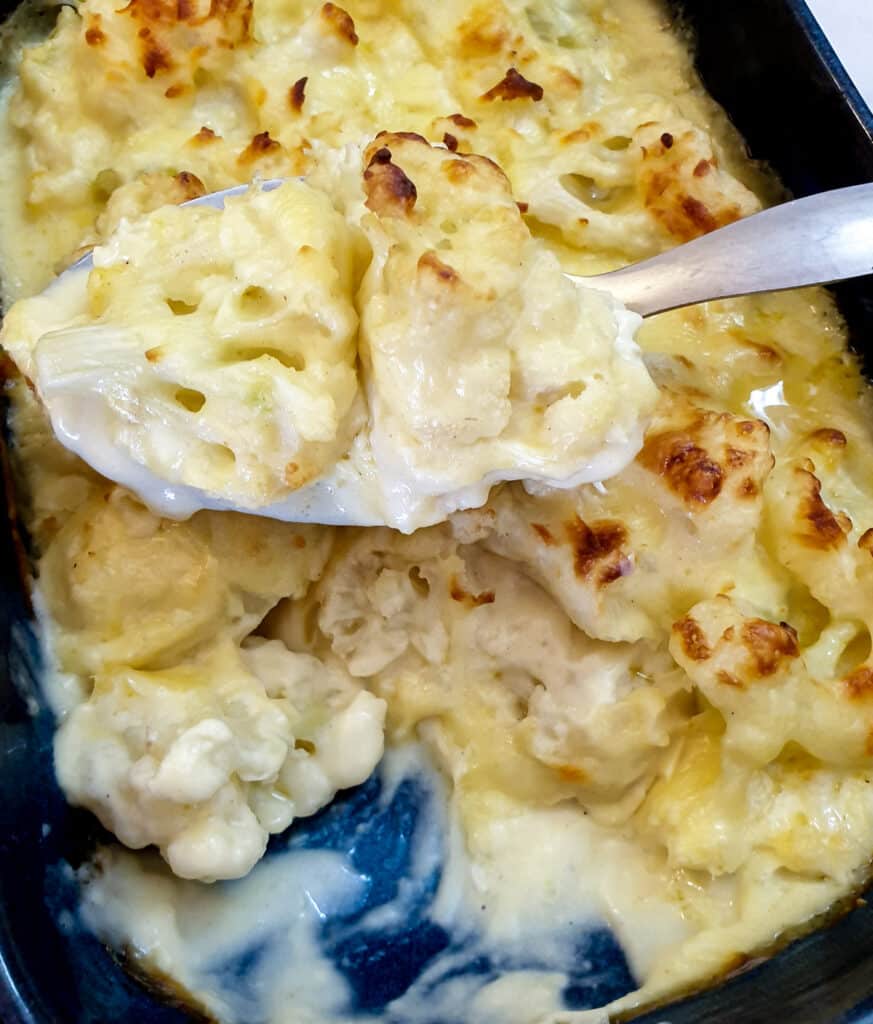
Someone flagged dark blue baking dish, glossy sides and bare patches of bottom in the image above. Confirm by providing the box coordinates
[0,0,873,1024]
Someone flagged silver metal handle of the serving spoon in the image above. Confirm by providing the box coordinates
[573,183,873,316]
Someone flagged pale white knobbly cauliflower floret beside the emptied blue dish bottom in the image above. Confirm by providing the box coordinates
[55,640,385,882]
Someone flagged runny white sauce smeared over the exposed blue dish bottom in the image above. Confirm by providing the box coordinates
[83,745,686,1024]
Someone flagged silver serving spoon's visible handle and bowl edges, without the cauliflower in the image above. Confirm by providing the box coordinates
[30,178,873,528]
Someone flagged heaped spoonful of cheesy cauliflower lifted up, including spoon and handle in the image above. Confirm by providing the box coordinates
[0,133,873,531]
